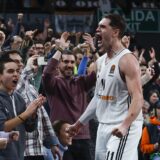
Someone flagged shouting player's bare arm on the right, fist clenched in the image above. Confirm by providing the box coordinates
[112,54,143,137]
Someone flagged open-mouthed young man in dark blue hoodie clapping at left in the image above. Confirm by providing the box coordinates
[0,54,45,160]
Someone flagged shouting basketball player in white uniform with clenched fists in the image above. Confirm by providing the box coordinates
[68,14,143,160]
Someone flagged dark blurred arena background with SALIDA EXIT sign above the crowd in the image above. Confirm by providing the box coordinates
[0,0,160,59]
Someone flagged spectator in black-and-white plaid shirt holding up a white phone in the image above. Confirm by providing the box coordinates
[5,51,58,160]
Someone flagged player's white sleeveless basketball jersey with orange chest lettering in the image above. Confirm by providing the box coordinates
[95,49,142,124]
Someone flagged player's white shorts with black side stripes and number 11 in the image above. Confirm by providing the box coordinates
[95,121,143,160]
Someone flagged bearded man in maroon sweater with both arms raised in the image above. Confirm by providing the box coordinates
[42,32,96,160]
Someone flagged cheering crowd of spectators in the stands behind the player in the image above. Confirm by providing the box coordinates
[0,12,160,160]
